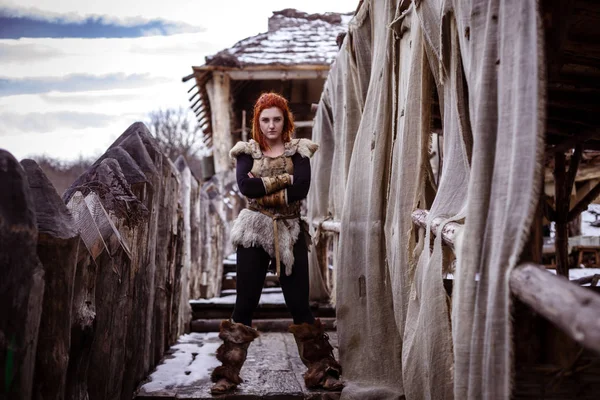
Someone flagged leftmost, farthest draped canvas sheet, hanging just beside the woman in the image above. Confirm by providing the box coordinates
[308,7,372,300]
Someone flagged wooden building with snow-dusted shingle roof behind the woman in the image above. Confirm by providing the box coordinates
[183,9,351,173]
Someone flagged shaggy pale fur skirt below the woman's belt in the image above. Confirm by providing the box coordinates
[231,209,300,275]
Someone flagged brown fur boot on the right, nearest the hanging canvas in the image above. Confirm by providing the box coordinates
[289,318,344,390]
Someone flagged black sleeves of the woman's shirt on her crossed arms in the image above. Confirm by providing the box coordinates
[236,153,310,204]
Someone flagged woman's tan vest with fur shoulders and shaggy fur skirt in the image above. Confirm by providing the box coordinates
[229,139,319,275]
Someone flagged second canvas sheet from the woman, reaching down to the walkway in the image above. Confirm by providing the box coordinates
[336,1,403,400]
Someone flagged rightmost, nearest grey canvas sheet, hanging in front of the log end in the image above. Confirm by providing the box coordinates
[452,0,546,399]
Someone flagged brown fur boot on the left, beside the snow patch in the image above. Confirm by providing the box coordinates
[210,320,258,394]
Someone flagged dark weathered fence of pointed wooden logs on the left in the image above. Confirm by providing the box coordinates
[0,123,236,400]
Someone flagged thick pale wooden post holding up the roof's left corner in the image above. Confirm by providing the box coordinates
[206,71,233,173]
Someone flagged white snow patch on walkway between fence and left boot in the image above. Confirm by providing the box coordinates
[143,332,221,393]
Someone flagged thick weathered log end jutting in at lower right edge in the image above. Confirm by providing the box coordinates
[509,264,600,353]
